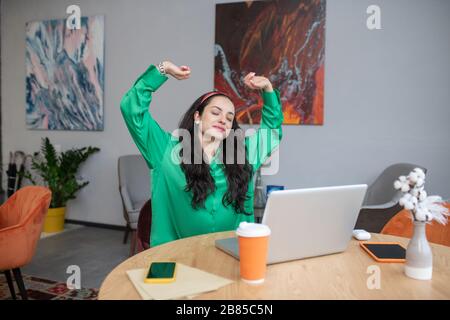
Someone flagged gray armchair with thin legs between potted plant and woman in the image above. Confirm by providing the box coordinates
[118,155,151,256]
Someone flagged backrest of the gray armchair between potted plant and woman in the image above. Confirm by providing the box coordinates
[118,154,150,210]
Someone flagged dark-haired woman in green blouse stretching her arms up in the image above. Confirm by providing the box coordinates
[121,61,283,247]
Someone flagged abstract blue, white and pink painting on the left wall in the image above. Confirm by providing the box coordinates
[26,15,104,131]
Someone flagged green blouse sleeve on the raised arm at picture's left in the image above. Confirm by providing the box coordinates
[120,65,171,169]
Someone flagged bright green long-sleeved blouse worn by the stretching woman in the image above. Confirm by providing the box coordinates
[120,65,283,247]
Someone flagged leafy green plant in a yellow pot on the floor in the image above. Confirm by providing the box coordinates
[23,138,100,232]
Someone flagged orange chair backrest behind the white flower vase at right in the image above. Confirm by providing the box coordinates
[381,203,450,246]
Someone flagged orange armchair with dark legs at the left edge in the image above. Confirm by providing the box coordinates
[0,186,52,299]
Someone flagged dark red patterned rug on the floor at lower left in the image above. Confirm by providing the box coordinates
[0,273,98,300]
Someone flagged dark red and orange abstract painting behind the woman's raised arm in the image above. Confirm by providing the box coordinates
[214,0,326,125]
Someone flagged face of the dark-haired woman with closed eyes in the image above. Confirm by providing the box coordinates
[195,96,234,140]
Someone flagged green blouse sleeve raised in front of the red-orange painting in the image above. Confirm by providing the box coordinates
[245,89,284,171]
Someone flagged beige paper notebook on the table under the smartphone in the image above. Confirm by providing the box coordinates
[127,263,233,300]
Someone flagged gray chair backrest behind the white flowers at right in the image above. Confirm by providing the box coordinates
[363,163,427,206]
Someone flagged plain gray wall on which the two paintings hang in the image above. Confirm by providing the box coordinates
[1,0,450,225]
